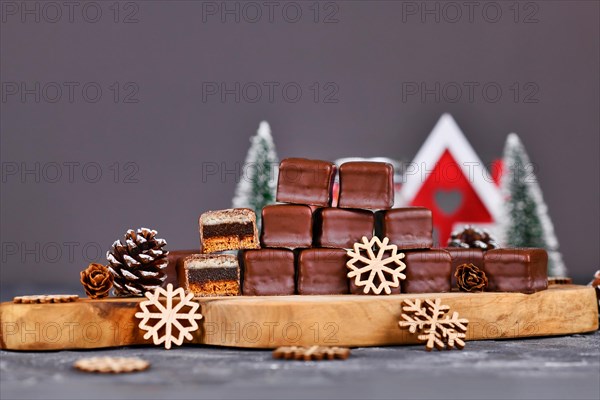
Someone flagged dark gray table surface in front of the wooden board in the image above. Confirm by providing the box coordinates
[0,332,600,399]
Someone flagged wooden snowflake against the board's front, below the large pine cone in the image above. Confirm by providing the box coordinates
[135,283,202,350]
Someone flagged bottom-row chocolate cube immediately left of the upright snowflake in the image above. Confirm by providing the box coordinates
[298,249,348,294]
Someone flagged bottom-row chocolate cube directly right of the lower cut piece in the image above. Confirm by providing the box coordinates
[240,249,296,296]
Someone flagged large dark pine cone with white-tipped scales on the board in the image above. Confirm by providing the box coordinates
[106,228,169,296]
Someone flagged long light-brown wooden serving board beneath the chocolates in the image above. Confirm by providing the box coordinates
[0,285,598,350]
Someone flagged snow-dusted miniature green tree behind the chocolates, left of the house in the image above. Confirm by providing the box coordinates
[233,121,279,224]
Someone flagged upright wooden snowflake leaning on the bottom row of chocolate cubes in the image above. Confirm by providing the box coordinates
[346,236,406,294]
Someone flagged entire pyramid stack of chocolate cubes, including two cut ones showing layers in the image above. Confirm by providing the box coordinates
[169,158,547,296]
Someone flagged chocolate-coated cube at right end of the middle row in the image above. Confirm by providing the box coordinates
[376,207,433,250]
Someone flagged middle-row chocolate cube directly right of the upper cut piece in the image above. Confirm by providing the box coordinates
[260,204,313,249]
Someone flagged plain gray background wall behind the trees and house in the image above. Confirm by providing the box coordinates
[0,1,600,290]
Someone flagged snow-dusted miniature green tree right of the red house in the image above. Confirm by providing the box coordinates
[501,133,566,276]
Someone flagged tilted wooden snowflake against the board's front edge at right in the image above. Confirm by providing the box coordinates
[399,299,469,351]
